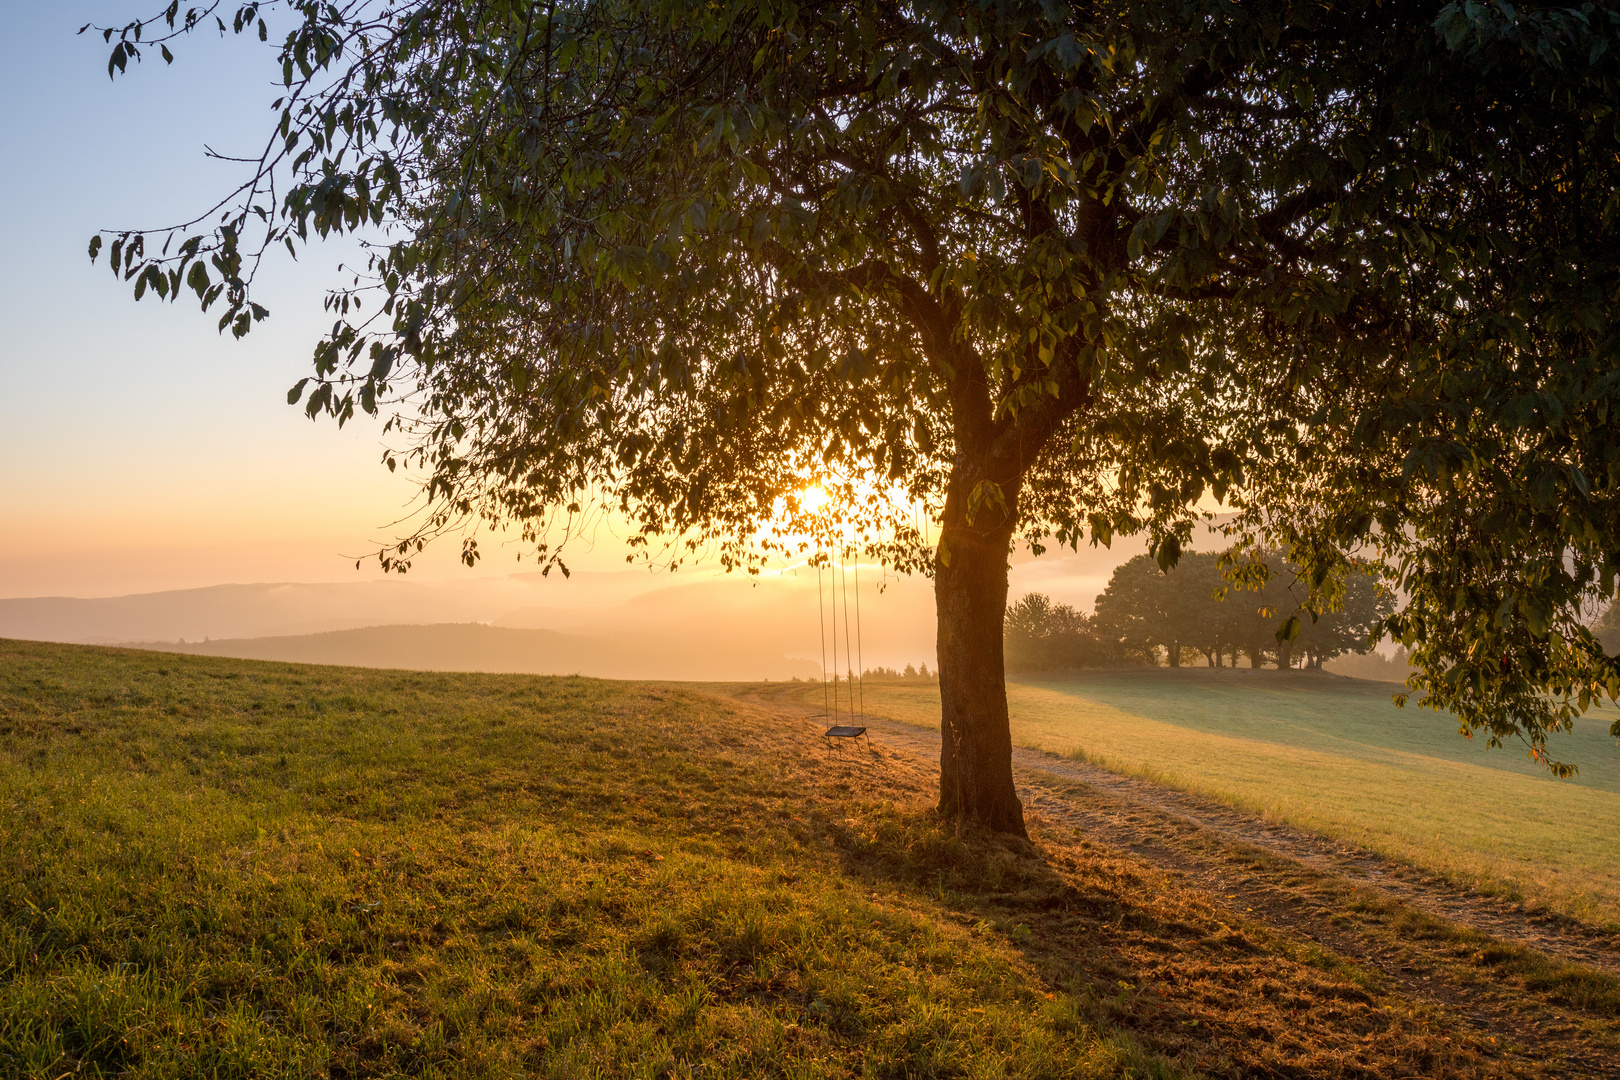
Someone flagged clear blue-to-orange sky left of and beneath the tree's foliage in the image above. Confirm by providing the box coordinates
[0,0,1134,667]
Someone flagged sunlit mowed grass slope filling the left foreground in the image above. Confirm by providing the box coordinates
[0,641,1179,1078]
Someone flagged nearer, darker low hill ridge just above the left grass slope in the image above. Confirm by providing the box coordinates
[131,623,820,682]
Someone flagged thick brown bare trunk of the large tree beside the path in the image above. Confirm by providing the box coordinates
[933,479,1029,837]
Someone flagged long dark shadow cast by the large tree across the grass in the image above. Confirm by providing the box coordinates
[829,803,1503,1078]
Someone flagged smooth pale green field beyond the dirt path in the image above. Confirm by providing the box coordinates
[816,669,1620,926]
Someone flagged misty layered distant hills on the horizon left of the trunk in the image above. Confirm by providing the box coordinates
[0,570,933,678]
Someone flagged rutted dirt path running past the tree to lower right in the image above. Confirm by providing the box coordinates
[740,688,1620,1078]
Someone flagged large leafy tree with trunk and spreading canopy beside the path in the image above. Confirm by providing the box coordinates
[91,0,1620,832]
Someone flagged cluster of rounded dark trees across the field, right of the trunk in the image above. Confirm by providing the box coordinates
[1004,552,1393,672]
